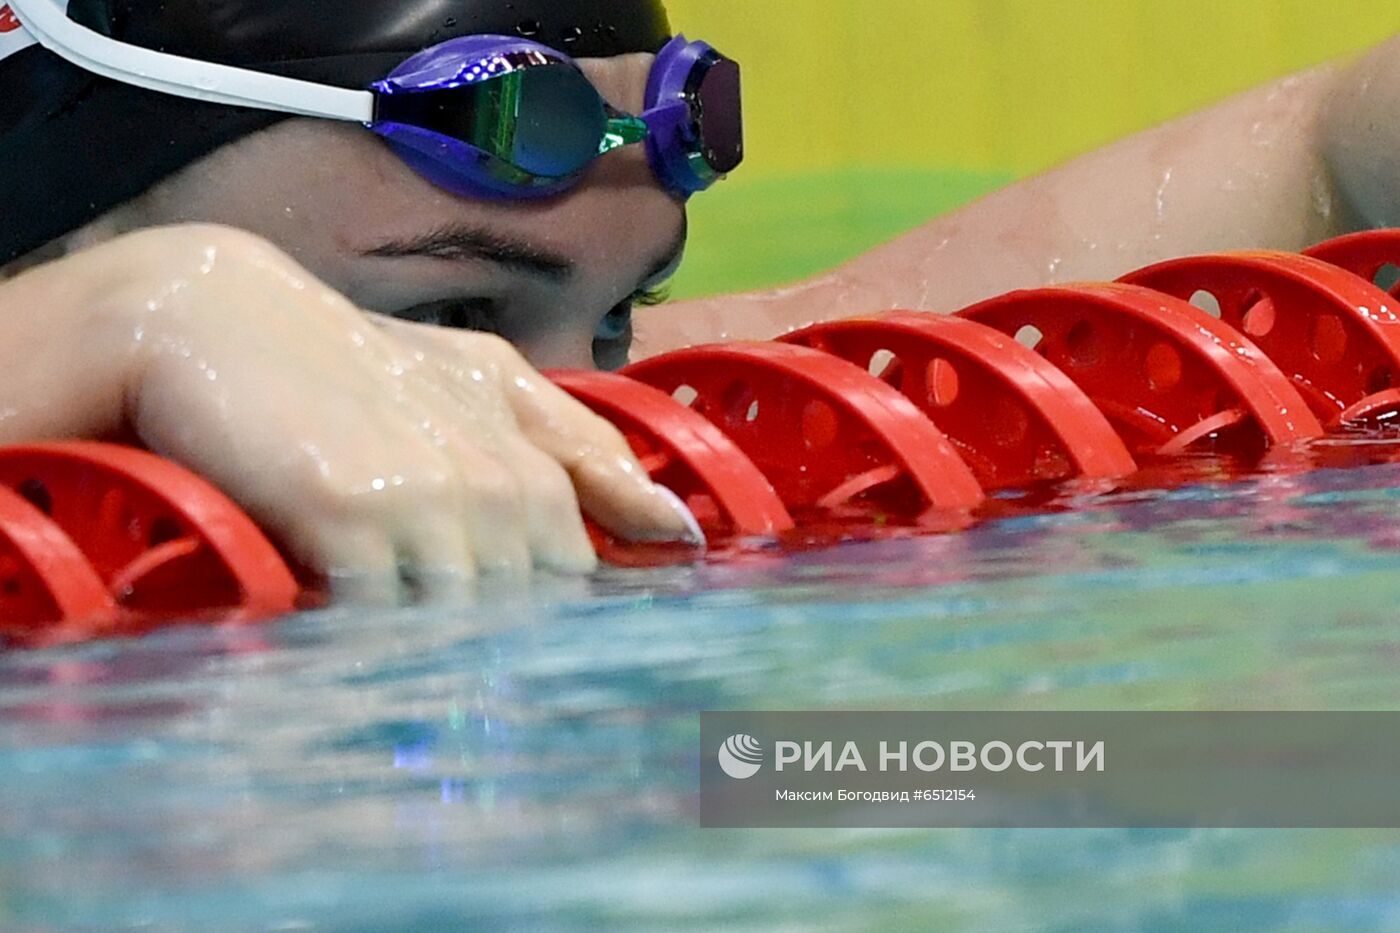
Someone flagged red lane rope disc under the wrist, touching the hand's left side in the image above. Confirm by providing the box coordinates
[0,441,298,618]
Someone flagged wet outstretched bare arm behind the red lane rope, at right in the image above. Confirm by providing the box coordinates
[634,38,1377,359]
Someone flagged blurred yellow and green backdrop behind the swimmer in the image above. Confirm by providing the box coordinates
[666,0,1400,296]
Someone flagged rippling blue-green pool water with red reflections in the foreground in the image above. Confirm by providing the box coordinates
[0,448,1400,930]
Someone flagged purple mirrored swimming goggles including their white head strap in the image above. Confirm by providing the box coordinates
[7,0,743,199]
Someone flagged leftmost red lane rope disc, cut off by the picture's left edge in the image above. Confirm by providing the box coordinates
[0,486,118,635]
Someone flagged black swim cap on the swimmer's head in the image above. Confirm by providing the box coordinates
[0,0,671,263]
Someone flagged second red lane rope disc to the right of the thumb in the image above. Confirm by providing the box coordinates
[623,343,983,523]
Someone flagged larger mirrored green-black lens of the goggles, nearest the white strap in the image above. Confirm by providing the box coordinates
[375,63,608,178]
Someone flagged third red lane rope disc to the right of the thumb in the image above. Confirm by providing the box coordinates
[781,311,1137,490]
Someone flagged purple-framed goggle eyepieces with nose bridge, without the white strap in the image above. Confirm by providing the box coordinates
[368,36,743,199]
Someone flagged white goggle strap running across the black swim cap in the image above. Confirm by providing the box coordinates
[0,0,374,123]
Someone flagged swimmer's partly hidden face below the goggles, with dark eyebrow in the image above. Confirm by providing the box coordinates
[140,55,686,367]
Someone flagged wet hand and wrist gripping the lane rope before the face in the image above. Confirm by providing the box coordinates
[0,226,700,604]
